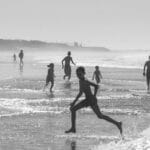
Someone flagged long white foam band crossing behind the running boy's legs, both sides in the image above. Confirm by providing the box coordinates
[0,98,144,115]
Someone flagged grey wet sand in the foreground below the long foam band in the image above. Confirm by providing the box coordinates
[0,110,150,150]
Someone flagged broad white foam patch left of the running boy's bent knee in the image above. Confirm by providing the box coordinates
[0,98,68,116]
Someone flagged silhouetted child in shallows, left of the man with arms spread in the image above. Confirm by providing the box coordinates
[44,63,55,92]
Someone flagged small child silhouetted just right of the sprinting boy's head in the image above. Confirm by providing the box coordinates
[92,66,103,84]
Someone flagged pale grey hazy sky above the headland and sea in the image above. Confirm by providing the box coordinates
[0,0,150,49]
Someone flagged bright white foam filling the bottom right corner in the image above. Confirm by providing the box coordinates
[91,125,150,150]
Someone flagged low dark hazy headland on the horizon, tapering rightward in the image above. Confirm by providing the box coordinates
[0,39,110,51]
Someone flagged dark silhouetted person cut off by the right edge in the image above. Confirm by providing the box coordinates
[143,56,150,91]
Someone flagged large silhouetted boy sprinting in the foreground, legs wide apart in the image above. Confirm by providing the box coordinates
[65,67,122,134]
